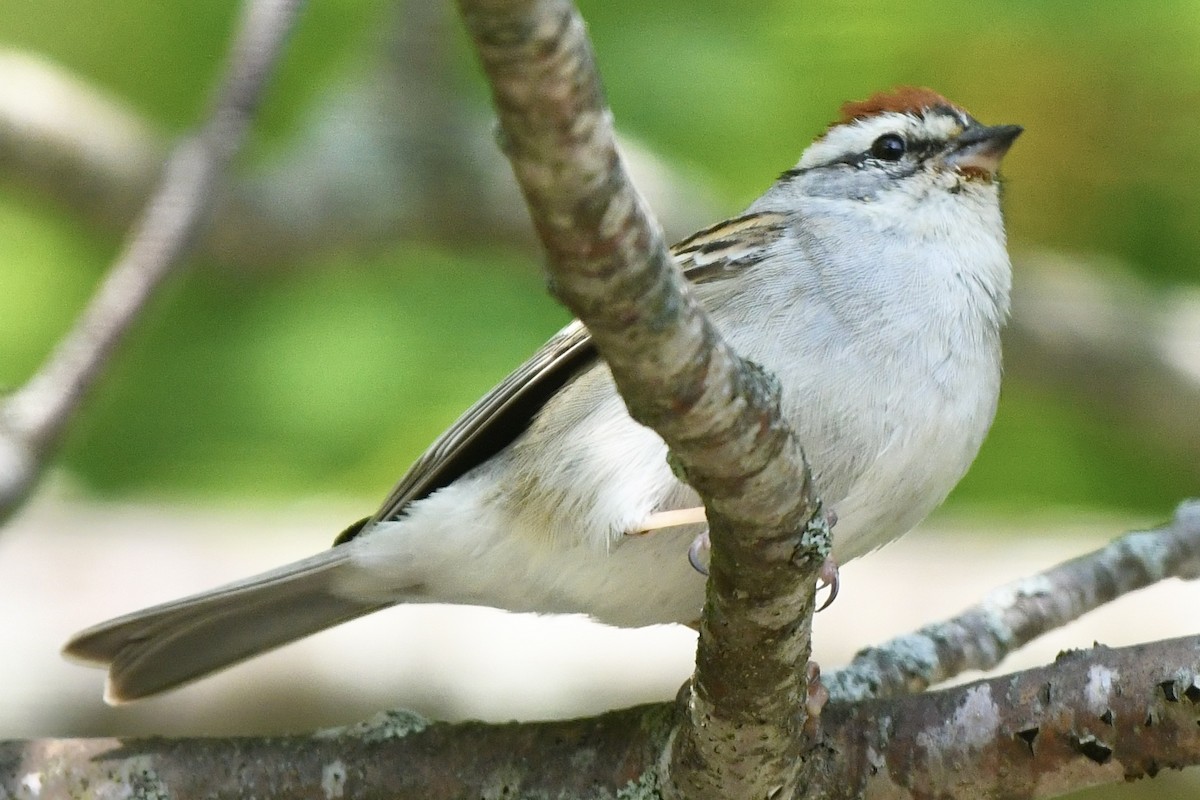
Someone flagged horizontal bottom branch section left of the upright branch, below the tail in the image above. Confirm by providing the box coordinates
[0,704,672,800]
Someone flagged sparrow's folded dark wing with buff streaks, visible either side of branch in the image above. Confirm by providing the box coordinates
[352,212,788,534]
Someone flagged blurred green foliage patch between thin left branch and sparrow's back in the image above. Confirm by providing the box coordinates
[52,246,566,498]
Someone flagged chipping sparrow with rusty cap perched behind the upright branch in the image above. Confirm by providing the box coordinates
[66,88,1021,702]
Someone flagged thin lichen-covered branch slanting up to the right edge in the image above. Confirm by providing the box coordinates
[824,500,1200,700]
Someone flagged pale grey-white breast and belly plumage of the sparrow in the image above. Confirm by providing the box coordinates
[346,185,1008,626]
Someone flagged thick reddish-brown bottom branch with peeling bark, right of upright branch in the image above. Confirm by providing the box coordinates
[808,637,1200,800]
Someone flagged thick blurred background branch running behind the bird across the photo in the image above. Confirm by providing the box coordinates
[9,47,1200,477]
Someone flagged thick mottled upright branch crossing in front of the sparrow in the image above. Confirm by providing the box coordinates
[458,0,828,800]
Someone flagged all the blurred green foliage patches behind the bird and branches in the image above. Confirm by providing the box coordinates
[0,0,1200,510]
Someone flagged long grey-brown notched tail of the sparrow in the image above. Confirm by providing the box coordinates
[62,547,388,704]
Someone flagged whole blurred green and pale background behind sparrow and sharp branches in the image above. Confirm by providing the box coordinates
[0,0,1200,796]
